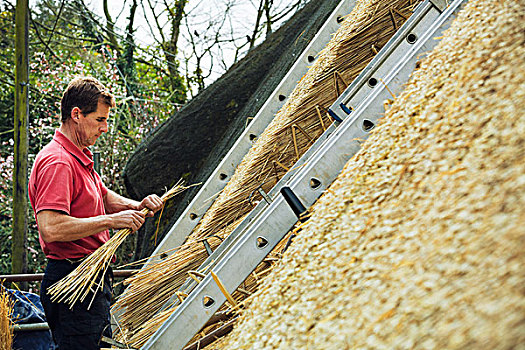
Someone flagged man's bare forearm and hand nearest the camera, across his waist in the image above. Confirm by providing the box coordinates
[36,210,145,242]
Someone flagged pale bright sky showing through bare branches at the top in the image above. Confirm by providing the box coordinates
[81,0,302,85]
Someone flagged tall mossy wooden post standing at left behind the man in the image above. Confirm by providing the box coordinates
[11,0,29,273]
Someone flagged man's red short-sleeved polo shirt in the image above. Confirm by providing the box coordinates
[29,130,109,259]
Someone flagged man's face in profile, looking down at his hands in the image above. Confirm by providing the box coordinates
[77,101,109,148]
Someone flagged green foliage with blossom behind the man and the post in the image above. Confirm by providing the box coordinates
[0,1,187,274]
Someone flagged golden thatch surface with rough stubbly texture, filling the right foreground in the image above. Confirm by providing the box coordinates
[212,0,525,349]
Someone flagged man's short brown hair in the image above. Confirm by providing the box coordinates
[60,77,115,122]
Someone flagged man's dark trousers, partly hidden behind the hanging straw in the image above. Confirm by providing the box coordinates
[40,259,113,350]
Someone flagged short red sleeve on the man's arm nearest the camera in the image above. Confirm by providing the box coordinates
[34,162,74,215]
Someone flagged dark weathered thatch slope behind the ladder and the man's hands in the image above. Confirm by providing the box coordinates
[124,0,339,258]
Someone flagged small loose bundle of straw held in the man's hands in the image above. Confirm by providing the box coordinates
[47,180,193,309]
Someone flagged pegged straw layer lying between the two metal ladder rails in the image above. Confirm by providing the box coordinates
[112,0,420,344]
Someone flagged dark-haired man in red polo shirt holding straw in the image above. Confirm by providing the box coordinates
[29,77,162,350]
